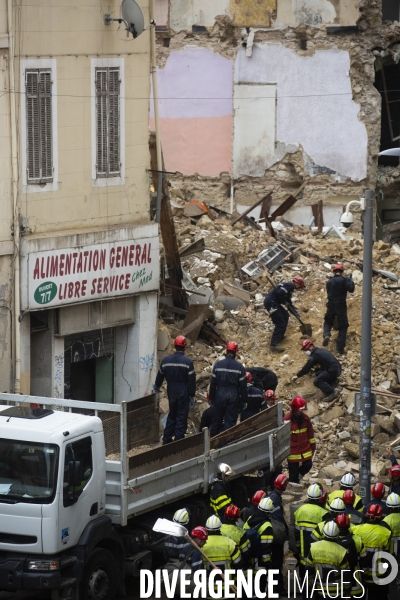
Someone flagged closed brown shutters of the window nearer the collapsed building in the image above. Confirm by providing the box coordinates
[96,67,121,177]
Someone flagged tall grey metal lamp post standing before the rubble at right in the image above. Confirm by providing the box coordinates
[359,190,374,506]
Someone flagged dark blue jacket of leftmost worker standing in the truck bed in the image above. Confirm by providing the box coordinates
[156,351,196,398]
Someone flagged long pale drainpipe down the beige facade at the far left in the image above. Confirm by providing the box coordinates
[7,0,21,394]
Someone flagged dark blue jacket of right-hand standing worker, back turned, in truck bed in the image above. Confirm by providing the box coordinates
[209,354,247,404]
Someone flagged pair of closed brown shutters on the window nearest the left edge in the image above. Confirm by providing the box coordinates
[25,69,53,184]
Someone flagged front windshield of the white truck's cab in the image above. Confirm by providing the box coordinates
[0,438,59,504]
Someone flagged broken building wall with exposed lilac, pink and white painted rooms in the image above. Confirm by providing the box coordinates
[150,0,400,237]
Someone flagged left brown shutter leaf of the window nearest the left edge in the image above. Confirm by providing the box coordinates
[26,71,40,181]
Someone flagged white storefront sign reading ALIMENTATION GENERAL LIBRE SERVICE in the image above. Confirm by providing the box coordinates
[28,238,159,310]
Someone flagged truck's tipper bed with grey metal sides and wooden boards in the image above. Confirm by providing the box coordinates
[0,394,290,525]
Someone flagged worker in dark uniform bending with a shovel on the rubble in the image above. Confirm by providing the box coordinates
[264,277,305,352]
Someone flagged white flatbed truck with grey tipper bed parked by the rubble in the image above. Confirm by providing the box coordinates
[0,394,289,600]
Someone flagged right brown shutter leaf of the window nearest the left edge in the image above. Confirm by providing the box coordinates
[39,71,53,180]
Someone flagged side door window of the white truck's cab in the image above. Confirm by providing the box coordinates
[63,437,93,506]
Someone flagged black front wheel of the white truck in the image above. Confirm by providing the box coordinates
[80,548,117,600]
